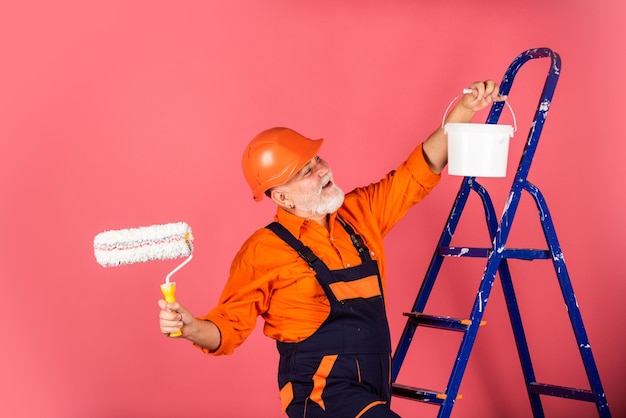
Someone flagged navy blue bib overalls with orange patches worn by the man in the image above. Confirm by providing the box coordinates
[267,219,399,418]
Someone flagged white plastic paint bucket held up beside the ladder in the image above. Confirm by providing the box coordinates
[444,94,517,177]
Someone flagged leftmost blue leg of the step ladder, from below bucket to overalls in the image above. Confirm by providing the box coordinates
[391,178,471,383]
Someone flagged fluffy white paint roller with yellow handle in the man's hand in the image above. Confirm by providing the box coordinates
[93,222,193,337]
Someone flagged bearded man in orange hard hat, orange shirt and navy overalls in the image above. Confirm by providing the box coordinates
[159,81,504,418]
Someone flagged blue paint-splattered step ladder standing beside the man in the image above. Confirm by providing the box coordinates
[392,48,611,418]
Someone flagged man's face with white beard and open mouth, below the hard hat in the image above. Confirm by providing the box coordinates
[283,156,344,215]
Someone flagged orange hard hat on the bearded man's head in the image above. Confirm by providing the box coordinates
[241,127,324,202]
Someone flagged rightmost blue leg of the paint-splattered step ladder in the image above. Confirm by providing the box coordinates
[526,182,611,418]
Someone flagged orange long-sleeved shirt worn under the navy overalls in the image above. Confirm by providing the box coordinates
[199,145,440,355]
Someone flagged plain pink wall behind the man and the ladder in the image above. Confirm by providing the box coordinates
[0,0,626,418]
